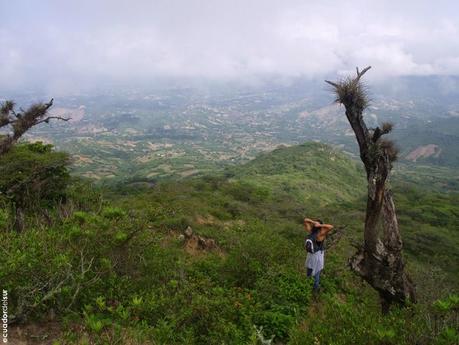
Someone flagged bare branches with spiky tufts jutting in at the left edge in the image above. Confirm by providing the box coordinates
[0,99,69,155]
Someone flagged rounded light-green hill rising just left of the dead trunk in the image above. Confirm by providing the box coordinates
[229,143,365,205]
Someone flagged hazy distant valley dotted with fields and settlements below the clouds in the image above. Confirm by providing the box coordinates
[5,76,459,180]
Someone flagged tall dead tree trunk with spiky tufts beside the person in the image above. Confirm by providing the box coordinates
[326,66,416,313]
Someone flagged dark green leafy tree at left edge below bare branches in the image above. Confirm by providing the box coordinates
[0,142,69,231]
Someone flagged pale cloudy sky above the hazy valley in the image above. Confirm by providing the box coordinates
[0,0,459,89]
